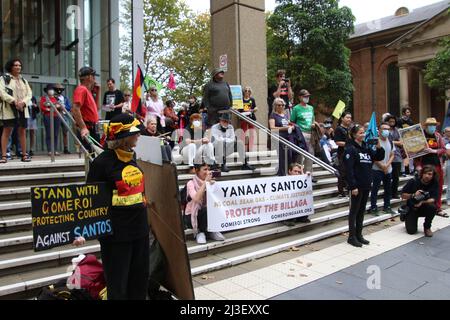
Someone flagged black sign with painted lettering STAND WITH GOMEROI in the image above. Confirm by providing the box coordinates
[31,183,113,251]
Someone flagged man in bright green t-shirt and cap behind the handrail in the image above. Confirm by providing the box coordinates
[291,89,317,182]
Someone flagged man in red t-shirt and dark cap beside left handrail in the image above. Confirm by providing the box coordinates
[71,67,100,150]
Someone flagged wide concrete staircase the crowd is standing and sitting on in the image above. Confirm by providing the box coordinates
[0,152,408,299]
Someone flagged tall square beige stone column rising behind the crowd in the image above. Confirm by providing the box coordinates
[210,0,268,151]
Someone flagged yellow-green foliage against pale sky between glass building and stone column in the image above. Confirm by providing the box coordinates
[120,0,211,101]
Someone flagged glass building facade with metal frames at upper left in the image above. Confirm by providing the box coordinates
[0,0,120,151]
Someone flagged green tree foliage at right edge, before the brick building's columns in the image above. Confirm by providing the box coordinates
[425,37,450,99]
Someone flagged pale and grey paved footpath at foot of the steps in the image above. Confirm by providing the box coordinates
[195,217,450,300]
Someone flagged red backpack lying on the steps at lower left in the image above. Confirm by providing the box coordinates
[67,255,106,300]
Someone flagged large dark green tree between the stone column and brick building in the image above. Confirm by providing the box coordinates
[267,0,355,115]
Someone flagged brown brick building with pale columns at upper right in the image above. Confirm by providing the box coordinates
[347,1,450,123]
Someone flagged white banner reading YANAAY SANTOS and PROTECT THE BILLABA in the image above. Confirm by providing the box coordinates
[207,175,314,232]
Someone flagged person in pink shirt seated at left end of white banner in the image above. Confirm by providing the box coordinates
[184,163,225,244]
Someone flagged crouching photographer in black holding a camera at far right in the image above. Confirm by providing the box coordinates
[400,165,439,237]
